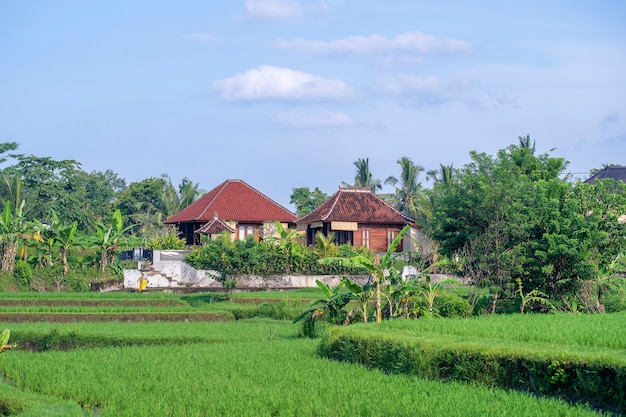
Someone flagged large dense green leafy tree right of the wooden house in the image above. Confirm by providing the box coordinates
[429,146,626,311]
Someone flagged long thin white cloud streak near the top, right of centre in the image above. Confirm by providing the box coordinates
[273,32,471,56]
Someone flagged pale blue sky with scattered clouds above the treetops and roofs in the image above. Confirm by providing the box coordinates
[0,0,626,211]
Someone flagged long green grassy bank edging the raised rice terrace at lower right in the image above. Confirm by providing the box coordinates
[319,325,626,414]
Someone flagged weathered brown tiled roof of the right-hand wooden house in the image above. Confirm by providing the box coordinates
[296,188,415,224]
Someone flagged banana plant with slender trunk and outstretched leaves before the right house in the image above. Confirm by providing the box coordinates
[318,225,410,323]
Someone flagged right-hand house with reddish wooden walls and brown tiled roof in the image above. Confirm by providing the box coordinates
[296,188,419,252]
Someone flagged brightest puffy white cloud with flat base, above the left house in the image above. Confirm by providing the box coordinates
[214,65,353,102]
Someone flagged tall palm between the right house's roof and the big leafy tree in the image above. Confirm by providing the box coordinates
[385,156,424,218]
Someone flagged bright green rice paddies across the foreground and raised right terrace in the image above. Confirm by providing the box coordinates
[0,294,624,417]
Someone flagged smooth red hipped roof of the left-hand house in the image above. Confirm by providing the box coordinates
[165,180,296,223]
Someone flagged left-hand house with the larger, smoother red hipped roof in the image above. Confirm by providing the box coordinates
[165,179,296,245]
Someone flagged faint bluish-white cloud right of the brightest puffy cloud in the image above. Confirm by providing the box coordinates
[375,74,502,107]
